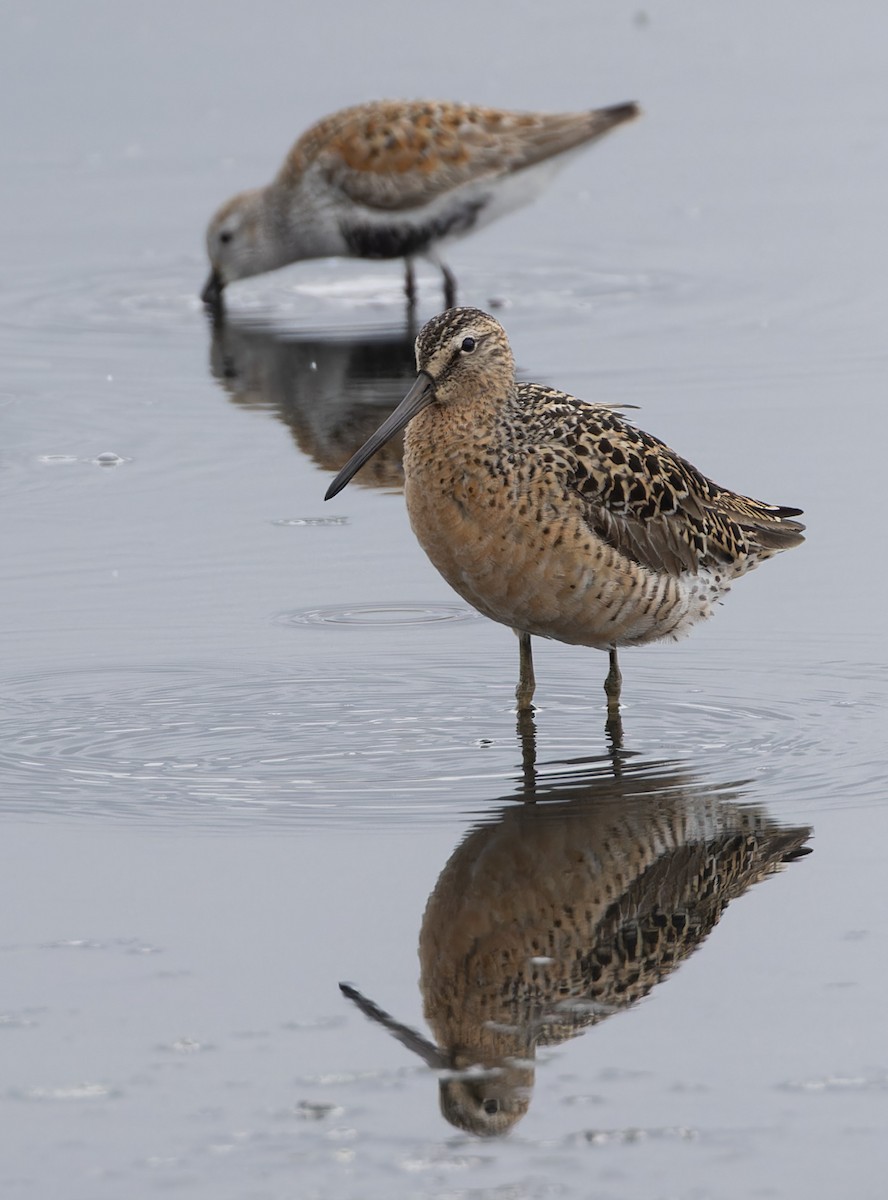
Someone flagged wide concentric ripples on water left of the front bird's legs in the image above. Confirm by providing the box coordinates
[0,666,523,823]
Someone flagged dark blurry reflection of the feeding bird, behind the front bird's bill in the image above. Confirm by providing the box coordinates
[210,320,415,487]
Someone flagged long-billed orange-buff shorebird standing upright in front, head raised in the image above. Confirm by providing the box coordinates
[325,308,804,720]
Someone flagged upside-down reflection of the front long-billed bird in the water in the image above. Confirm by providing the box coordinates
[340,729,811,1136]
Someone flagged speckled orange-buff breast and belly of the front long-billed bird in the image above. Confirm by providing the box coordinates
[404,414,720,649]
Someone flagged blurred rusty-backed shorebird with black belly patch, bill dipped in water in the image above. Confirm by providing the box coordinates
[202,100,640,307]
